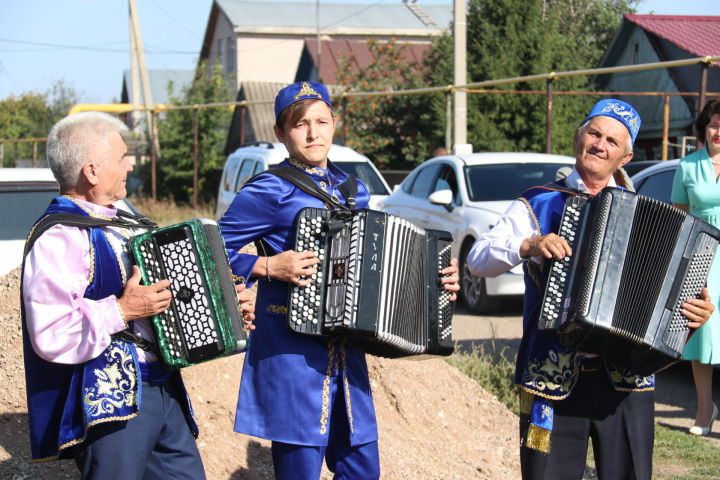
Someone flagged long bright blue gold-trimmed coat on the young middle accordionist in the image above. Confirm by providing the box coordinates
[219,160,377,446]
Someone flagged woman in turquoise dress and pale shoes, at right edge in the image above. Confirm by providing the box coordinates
[671,100,720,435]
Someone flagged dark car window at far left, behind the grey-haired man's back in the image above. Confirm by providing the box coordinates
[0,186,58,240]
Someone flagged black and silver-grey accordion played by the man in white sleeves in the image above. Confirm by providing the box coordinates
[539,187,720,376]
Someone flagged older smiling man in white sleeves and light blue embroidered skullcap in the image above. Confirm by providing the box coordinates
[468,100,713,480]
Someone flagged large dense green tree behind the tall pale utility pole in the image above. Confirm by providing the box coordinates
[428,0,637,154]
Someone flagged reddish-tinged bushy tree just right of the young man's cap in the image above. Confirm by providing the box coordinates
[338,39,443,168]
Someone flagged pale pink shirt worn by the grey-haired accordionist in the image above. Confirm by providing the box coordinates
[23,199,156,364]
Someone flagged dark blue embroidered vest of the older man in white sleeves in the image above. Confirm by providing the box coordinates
[515,181,655,400]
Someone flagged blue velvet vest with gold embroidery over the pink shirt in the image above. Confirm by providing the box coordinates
[21,197,141,460]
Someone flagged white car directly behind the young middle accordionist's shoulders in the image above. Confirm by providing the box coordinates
[215,142,390,219]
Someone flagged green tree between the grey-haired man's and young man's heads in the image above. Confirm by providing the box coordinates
[155,66,234,202]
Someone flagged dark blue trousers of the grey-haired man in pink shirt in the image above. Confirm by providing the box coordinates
[74,376,205,480]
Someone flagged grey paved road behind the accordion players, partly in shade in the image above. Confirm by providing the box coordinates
[453,299,720,446]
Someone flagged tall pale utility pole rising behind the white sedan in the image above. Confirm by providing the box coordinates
[453,0,472,155]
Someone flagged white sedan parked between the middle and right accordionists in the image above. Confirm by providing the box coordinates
[383,153,575,313]
